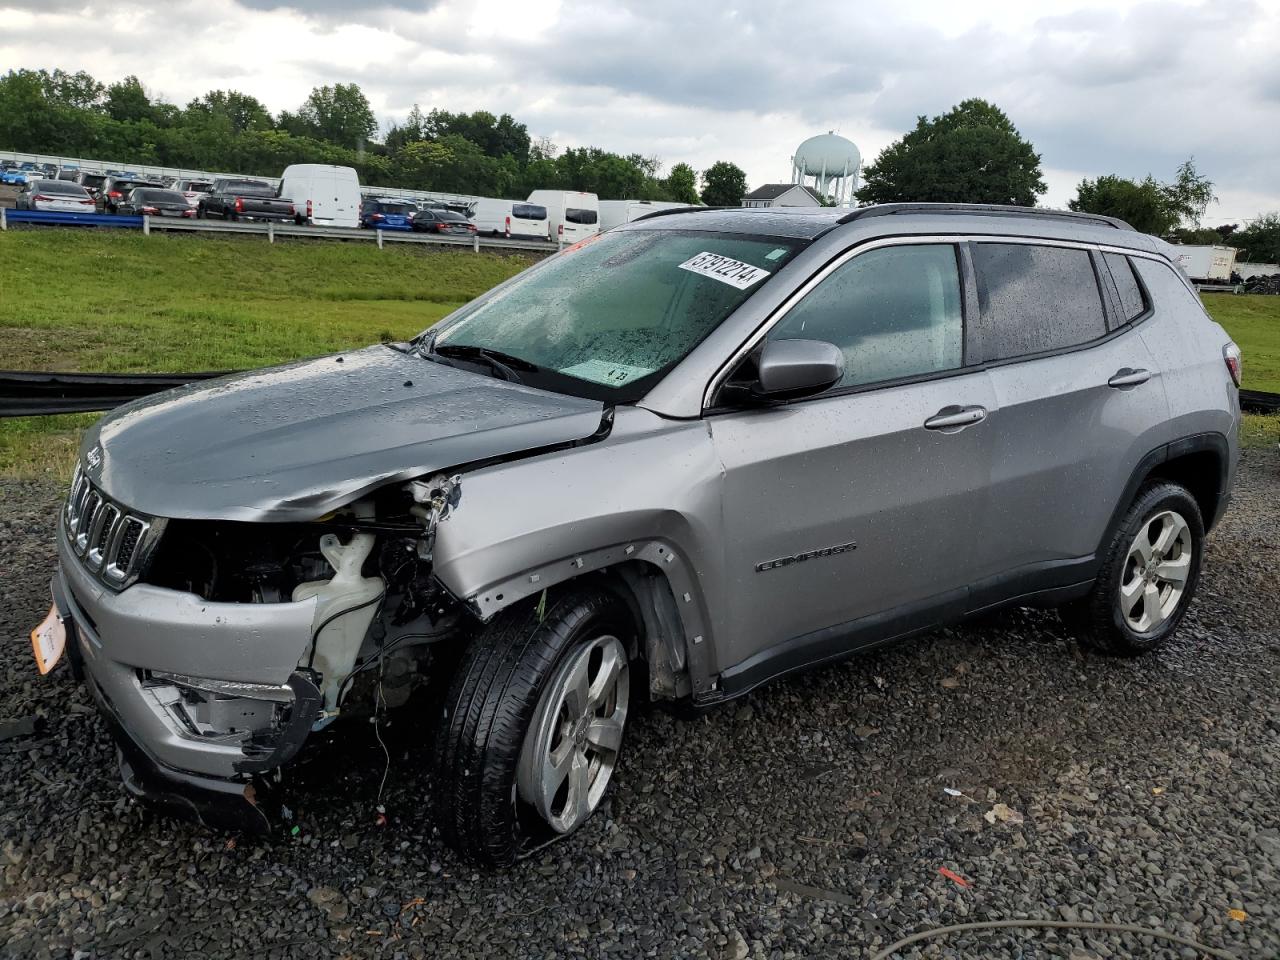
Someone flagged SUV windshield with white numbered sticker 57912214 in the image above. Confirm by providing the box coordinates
[434,230,801,402]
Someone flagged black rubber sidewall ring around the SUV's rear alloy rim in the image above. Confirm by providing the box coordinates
[1098,484,1204,653]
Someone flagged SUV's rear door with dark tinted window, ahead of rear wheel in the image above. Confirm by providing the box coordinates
[969,238,1169,593]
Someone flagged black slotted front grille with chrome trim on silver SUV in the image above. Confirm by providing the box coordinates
[65,466,164,590]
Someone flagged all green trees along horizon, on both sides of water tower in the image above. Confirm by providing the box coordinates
[0,69,1280,261]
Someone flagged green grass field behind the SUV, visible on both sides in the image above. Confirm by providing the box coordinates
[0,229,1280,476]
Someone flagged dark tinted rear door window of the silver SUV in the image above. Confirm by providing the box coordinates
[972,243,1107,361]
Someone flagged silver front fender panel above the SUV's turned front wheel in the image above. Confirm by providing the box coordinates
[431,407,724,695]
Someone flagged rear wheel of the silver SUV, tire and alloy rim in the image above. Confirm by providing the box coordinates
[1062,481,1204,657]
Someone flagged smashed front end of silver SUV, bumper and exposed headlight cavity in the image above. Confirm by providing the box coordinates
[54,474,468,828]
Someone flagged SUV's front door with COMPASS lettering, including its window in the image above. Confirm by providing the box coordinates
[708,242,993,692]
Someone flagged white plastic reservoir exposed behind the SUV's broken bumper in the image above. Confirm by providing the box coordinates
[293,534,385,718]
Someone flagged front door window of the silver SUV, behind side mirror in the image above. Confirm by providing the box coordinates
[769,243,964,387]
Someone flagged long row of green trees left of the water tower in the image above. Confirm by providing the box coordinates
[0,69,746,206]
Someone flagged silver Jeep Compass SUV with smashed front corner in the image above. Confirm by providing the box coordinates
[46,205,1240,864]
